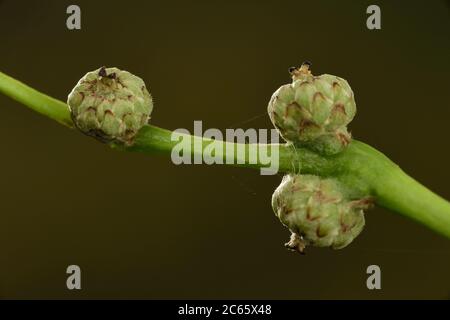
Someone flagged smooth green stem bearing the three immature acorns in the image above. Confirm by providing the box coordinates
[0,72,450,238]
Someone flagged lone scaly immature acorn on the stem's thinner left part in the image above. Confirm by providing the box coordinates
[67,67,153,145]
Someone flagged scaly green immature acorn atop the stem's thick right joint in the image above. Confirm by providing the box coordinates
[268,62,356,155]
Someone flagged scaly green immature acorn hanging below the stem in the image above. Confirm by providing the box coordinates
[272,174,372,252]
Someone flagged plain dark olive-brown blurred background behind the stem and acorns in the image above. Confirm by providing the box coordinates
[0,0,450,299]
